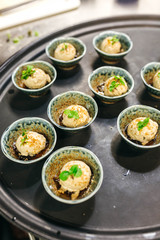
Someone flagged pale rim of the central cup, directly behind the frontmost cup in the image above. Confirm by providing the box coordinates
[47,91,98,131]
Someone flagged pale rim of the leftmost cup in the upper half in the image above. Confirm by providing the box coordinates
[12,60,57,93]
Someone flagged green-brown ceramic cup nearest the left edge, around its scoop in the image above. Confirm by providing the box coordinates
[1,117,57,164]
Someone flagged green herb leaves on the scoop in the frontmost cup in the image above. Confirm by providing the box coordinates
[59,165,82,181]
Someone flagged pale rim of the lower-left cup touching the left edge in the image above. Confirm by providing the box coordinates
[1,117,57,164]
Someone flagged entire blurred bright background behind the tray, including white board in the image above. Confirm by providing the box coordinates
[0,0,160,65]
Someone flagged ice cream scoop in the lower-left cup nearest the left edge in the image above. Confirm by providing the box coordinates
[16,131,46,157]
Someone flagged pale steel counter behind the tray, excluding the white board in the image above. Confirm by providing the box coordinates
[0,0,160,65]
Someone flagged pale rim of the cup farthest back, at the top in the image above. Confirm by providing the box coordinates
[92,31,133,57]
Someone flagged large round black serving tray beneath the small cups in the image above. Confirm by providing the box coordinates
[0,16,160,240]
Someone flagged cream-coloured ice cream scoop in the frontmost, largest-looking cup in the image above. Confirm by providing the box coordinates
[59,160,91,199]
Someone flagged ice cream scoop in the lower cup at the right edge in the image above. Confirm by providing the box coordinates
[127,117,158,145]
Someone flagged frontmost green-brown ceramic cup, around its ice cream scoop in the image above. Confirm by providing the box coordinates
[42,146,103,204]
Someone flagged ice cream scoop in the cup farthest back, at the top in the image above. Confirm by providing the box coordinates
[100,37,121,54]
